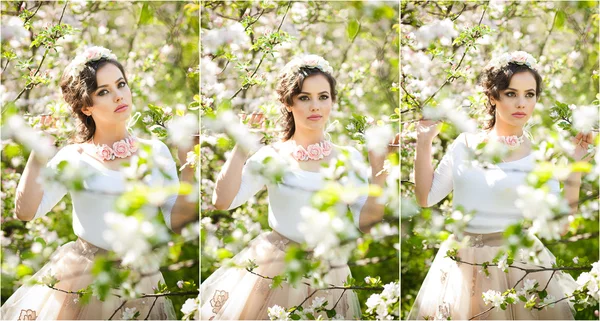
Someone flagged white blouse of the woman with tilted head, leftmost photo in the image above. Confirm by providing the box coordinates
[34,139,179,250]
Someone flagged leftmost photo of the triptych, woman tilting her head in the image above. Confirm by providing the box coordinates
[0,1,200,320]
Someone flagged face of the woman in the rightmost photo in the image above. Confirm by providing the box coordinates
[490,72,537,128]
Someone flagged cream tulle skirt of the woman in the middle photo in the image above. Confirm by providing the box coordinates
[200,231,361,320]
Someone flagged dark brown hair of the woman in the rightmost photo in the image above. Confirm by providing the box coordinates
[479,63,542,130]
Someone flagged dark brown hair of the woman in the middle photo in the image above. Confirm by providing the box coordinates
[276,67,337,141]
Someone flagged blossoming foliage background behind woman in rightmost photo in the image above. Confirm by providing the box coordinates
[401,1,599,319]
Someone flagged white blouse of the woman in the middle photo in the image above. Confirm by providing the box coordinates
[229,145,369,243]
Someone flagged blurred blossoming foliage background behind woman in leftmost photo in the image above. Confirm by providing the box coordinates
[0,1,199,317]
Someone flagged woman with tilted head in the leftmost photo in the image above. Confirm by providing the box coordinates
[1,47,194,320]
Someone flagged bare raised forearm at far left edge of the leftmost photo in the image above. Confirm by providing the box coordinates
[15,150,45,221]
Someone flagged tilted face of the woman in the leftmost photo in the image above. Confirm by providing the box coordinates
[82,63,132,126]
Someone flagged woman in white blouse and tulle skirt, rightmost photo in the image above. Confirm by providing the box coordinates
[408,52,592,320]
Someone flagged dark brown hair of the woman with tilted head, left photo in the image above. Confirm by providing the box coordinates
[60,58,129,143]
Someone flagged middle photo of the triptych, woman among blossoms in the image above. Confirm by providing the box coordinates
[200,1,400,320]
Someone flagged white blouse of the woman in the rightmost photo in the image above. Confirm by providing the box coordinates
[427,133,560,234]
